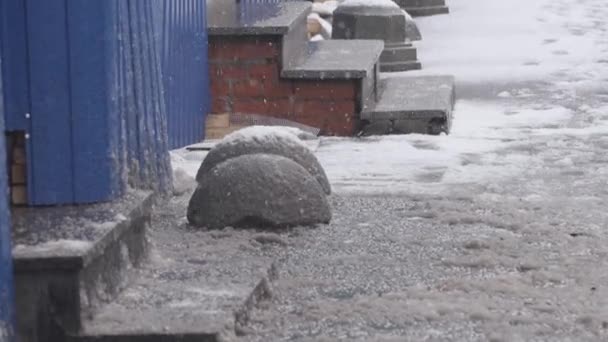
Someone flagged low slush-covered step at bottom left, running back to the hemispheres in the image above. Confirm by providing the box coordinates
[65,195,281,342]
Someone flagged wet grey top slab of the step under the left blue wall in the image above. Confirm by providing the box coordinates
[12,191,154,272]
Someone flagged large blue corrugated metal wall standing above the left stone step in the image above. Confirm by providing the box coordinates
[0,0,210,205]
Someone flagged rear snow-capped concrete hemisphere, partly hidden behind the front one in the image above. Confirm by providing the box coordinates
[196,126,331,194]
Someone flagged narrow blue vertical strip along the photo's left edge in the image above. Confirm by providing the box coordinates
[0,40,14,341]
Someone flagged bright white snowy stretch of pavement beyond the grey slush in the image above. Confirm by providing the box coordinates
[317,0,608,194]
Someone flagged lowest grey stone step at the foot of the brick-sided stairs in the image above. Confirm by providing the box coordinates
[361,76,455,135]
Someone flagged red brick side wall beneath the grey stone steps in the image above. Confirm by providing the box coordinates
[209,36,360,136]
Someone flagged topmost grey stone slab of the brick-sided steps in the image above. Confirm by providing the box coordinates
[207,0,311,35]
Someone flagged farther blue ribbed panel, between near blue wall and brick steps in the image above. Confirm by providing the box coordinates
[156,0,210,148]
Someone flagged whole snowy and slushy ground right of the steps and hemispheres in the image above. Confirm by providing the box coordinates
[172,0,608,341]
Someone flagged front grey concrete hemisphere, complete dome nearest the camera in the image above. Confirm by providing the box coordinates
[188,154,331,229]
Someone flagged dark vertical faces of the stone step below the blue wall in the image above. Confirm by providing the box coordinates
[15,192,159,340]
